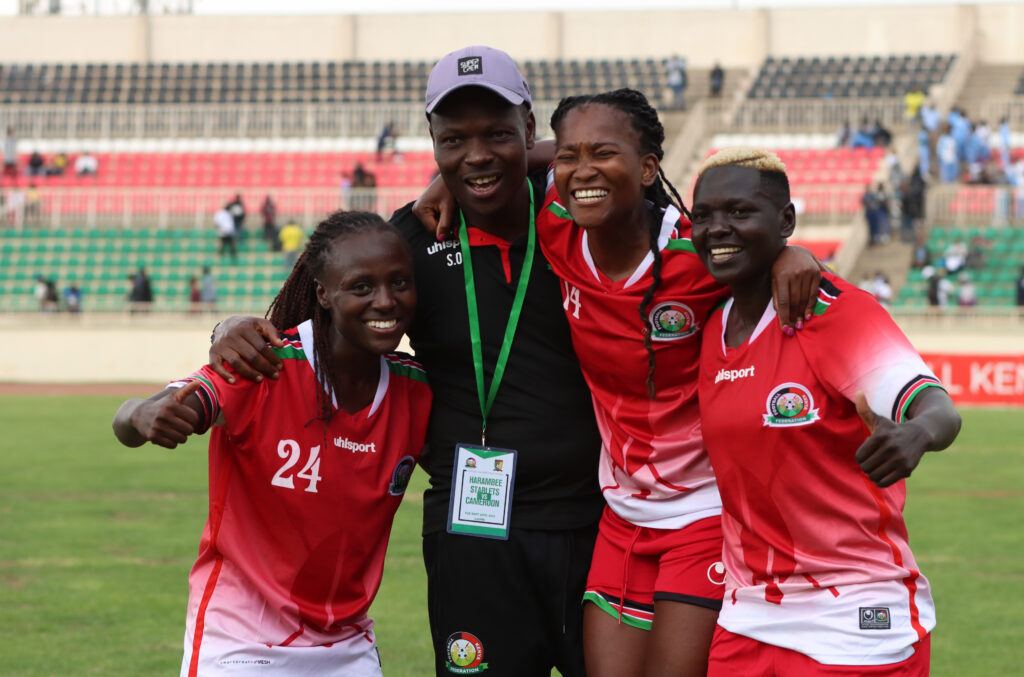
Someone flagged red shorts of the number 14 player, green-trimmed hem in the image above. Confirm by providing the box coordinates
[584,506,725,630]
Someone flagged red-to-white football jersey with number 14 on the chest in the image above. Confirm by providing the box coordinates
[537,175,725,528]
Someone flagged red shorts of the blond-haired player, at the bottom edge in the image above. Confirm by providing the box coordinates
[708,626,932,677]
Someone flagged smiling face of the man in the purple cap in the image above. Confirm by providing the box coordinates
[430,87,536,225]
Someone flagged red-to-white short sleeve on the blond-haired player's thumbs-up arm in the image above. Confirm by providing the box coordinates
[797,279,941,423]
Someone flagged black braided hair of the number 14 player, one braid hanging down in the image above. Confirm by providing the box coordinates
[551,88,690,399]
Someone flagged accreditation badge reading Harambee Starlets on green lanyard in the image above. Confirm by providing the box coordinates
[447,445,516,541]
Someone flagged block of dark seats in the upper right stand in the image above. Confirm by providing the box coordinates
[748,54,955,99]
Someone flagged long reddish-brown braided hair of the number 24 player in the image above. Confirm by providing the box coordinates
[266,211,404,421]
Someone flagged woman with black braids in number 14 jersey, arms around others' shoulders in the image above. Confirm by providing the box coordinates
[418,89,818,677]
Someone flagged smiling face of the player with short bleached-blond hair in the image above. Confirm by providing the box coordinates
[692,165,796,287]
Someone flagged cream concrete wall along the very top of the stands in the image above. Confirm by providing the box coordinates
[0,3,1024,68]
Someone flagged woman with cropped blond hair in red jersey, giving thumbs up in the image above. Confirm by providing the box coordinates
[692,149,961,677]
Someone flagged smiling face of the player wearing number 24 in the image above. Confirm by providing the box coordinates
[316,229,416,356]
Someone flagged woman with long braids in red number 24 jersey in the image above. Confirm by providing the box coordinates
[114,212,431,677]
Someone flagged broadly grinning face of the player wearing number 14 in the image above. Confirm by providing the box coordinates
[554,103,658,228]
